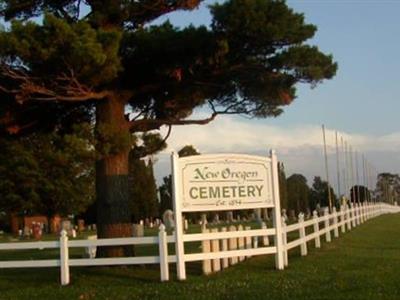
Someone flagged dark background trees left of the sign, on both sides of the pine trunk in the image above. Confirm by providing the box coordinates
[0,123,166,228]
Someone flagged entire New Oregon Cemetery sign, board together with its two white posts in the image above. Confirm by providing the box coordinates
[172,151,283,280]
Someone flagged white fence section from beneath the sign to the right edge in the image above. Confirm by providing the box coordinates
[188,203,400,274]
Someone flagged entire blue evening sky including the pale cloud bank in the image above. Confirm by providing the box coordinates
[152,0,400,192]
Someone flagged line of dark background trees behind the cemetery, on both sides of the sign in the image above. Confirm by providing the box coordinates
[0,123,400,231]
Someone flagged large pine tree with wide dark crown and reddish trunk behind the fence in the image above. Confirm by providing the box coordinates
[0,0,337,256]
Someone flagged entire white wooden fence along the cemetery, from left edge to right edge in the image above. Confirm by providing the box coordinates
[0,203,400,285]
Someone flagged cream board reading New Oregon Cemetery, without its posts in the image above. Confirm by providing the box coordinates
[178,154,274,212]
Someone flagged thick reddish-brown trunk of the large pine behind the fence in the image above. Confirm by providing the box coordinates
[96,99,133,257]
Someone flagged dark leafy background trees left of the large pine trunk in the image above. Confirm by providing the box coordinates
[0,124,95,217]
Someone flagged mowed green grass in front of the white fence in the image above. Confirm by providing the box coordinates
[0,214,400,300]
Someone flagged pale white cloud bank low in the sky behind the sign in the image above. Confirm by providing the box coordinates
[156,114,400,190]
